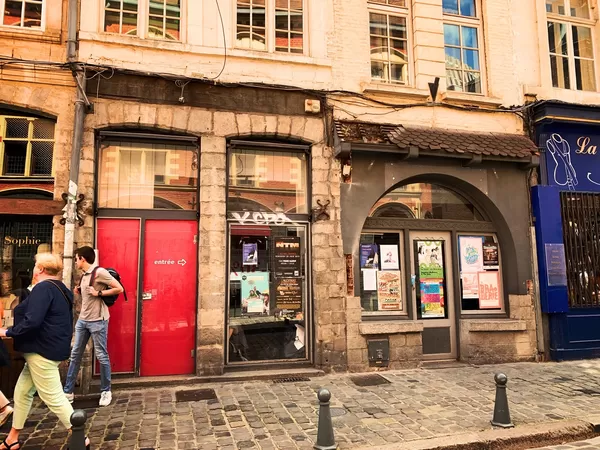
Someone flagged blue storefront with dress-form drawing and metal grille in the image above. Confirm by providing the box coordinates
[532,101,600,360]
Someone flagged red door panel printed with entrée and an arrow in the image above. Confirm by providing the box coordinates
[140,220,198,376]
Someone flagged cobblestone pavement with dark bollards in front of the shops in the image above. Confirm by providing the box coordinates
[3,360,600,450]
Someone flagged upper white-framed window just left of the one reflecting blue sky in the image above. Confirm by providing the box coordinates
[369,0,409,84]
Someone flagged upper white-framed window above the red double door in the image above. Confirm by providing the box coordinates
[103,0,182,41]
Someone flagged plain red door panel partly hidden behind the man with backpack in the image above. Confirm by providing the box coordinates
[96,219,140,373]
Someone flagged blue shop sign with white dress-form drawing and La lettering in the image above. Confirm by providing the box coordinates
[539,123,600,192]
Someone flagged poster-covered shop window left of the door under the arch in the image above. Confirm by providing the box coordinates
[360,233,407,316]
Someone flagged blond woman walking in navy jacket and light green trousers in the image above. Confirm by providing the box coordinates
[0,253,89,450]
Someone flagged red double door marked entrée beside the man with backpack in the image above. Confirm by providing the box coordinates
[96,219,198,376]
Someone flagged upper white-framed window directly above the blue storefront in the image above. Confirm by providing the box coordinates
[546,0,596,91]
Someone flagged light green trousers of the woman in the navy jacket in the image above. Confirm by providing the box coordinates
[13,353,73,430]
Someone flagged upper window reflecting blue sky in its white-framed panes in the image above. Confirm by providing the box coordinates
[443,0,482,94]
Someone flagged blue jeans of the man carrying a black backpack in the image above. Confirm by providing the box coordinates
[64,320,110,394]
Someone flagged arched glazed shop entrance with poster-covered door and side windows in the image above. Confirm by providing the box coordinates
[359,181,506,359]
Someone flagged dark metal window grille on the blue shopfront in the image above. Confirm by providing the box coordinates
[560,192,600,308]
